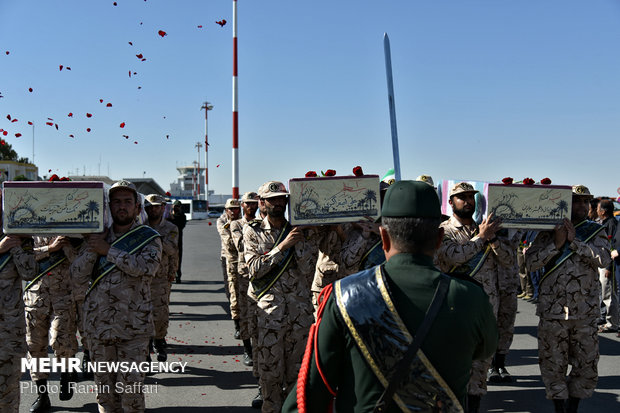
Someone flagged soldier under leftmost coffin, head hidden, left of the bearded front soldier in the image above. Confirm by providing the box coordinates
[24,237,77,413]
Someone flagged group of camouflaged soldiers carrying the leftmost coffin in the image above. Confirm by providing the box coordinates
[0,181,185,413]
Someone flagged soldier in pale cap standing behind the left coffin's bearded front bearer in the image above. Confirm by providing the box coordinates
[144,194,179,361]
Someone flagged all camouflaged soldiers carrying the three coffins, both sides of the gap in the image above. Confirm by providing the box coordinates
[0,172,618,413]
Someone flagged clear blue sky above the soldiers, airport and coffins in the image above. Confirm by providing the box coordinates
[0,0,620,196]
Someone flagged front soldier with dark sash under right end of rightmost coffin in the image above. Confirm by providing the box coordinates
[525,185,611,413]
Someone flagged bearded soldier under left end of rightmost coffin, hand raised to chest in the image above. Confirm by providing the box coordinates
[436,182,513,412]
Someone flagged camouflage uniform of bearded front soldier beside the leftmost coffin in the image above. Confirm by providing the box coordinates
[71,223,162,413]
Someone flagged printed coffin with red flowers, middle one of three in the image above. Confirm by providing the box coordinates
[289,175,381,225]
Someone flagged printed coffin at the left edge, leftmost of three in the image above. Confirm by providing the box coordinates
[2,181,107,234]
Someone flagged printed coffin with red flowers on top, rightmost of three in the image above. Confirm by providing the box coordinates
[487,184,573,230]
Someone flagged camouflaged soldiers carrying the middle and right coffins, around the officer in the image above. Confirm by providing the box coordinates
[218,175,617,413]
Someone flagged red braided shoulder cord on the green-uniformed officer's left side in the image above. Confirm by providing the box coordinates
[297,284,336,413]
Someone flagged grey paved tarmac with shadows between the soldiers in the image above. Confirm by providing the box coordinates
[20,221,620,413]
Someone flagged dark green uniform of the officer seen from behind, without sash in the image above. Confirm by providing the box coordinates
[282,180,498,413]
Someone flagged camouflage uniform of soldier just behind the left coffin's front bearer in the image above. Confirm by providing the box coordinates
[151,219,179,339]
